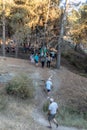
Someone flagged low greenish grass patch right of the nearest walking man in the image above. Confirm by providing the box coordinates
[57,106,87,129]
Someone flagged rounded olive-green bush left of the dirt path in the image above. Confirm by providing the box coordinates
[6,75,34,99]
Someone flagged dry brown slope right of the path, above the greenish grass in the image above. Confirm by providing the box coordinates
[57,71,87,113]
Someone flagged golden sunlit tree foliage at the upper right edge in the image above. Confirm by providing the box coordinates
[70,5,87,44]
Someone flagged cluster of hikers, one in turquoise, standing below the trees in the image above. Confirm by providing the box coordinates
[30,47,55,68]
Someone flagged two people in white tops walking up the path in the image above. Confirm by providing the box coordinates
[45,77,58,128]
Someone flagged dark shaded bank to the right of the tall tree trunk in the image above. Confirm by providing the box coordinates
[62,50,87,74]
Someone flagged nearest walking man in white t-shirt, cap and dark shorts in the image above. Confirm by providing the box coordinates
[48,98,58,128]
